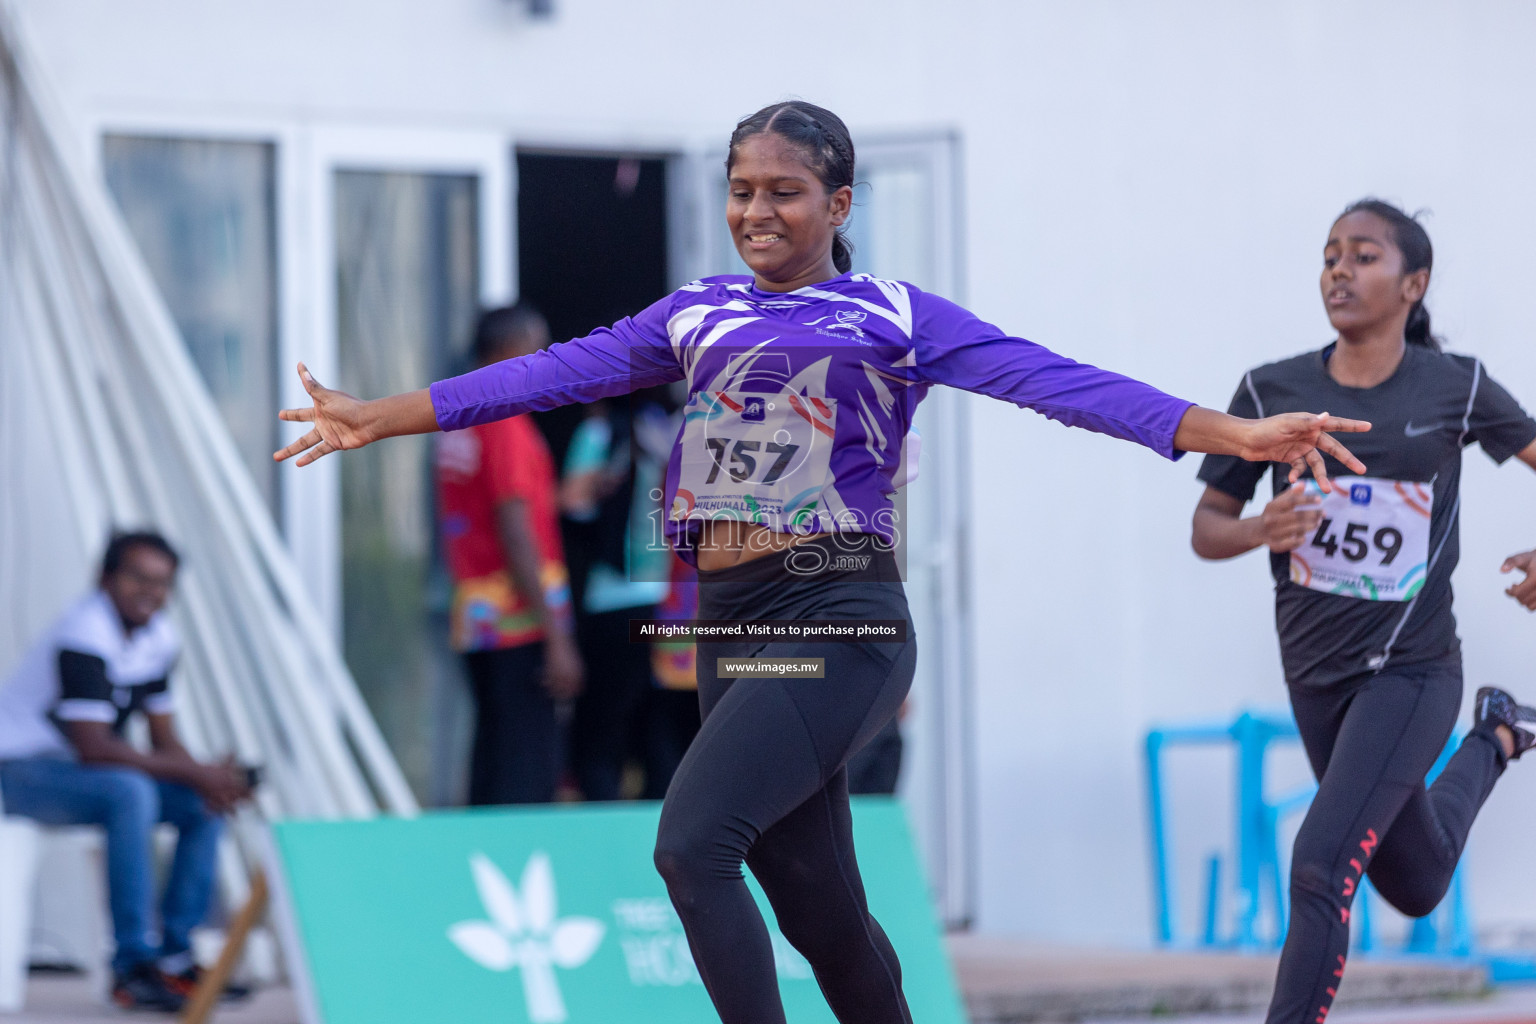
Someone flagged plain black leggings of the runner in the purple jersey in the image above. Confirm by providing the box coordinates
[656,539,917,1024]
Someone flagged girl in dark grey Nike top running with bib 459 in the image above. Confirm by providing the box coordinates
[1193,200,1536,1024]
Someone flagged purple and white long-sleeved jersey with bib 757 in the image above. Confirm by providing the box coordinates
[432,273,1192,560]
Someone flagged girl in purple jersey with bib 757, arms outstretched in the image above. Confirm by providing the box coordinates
[276,101,1369,1024]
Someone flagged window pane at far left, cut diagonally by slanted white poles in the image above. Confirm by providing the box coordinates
[101,135,278,513]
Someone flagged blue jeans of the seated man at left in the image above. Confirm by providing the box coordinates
[0,757,223,972]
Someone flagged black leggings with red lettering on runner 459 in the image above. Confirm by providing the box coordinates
[1266,654,1505,1024]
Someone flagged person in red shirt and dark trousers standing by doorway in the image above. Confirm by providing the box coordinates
[435,302,582,806]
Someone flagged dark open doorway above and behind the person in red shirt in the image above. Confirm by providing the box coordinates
[518,150,668,465]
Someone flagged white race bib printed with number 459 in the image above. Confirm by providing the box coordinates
[1290,476,1435,600]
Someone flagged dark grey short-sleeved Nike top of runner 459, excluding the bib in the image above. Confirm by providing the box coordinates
[1200,344,1536,686]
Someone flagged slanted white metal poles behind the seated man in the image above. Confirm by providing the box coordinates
[0,3,416,872]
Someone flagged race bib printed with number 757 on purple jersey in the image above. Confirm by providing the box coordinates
[671,391,837,530]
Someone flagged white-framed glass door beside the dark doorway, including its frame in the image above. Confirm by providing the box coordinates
[294,126,513,806]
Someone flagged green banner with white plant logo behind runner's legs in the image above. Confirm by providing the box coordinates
[265,798,965,1024]
